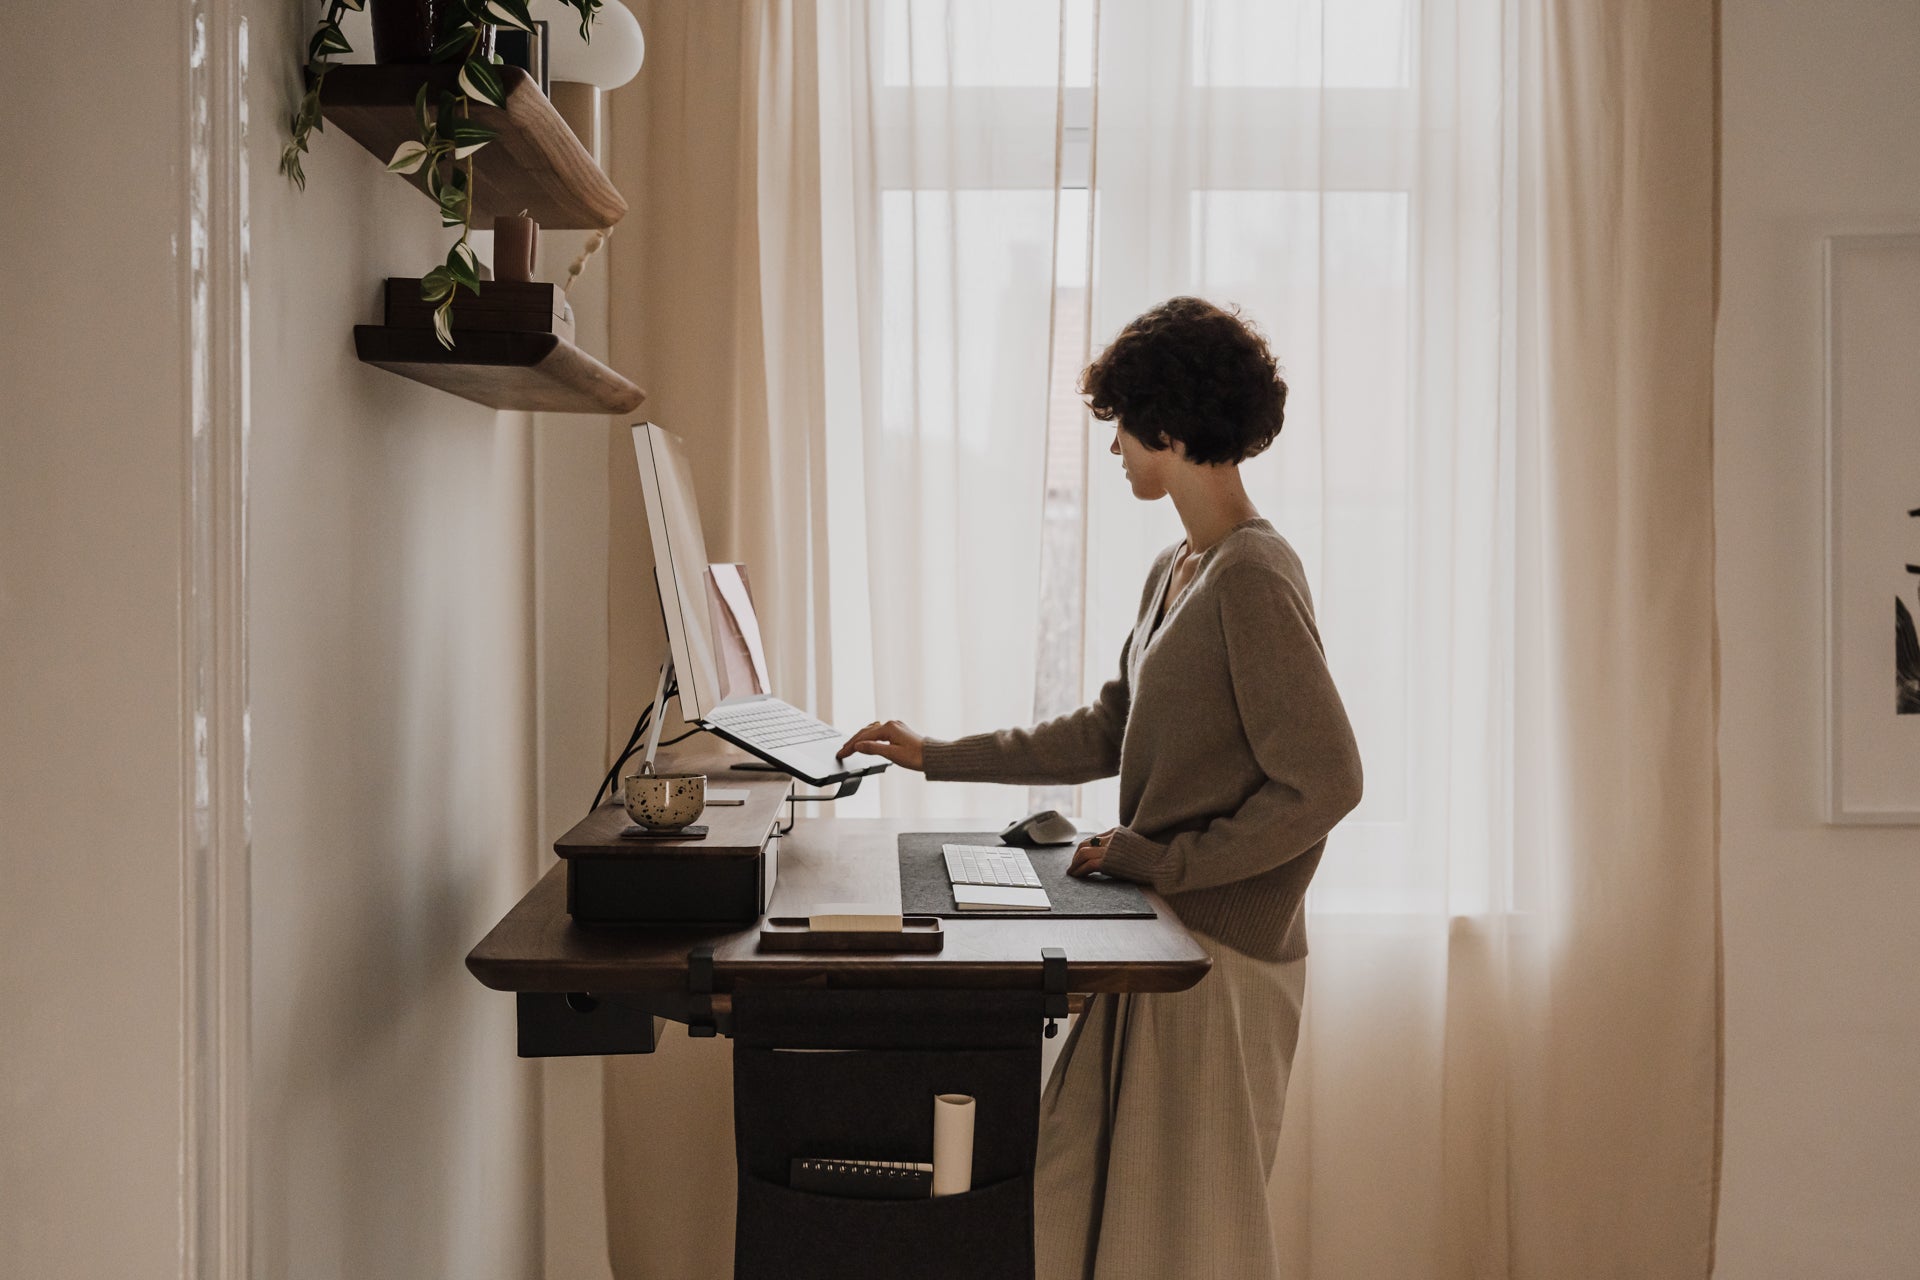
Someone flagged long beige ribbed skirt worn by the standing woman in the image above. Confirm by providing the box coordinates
[1035,935,1306,1280]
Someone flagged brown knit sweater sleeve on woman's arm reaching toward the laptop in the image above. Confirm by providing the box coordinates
[925,635,1133,787]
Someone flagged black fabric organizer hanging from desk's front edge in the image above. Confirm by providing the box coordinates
[733,988,1043,1280]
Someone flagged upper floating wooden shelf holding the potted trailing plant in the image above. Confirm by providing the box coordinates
[321,63,626,230]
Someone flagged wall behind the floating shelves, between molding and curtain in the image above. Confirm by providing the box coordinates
[250,0,607,1280]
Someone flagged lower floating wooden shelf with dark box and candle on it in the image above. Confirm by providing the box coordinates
[353,326,647,413]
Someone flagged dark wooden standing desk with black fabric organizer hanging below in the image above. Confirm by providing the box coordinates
[467,752,1212,1280]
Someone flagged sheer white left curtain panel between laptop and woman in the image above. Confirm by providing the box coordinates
[820,0,1064,818]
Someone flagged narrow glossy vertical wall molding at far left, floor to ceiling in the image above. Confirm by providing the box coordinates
[180,0,252,1280]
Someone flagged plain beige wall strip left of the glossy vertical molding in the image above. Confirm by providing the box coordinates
[0,4,188,1280]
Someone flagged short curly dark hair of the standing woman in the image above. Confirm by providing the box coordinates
[1079,297,1286,462]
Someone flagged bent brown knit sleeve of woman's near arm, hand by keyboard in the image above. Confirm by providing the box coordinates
[1102,564,1361,892]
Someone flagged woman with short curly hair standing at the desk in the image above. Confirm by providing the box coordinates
[841,297,1359,1280]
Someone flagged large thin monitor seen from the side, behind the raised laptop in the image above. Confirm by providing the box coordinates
[634,422,721,720]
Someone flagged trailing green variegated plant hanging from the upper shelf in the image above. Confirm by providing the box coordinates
[280,0,603,349]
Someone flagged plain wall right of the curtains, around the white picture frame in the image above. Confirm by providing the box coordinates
[1715,0,1920,1280]
